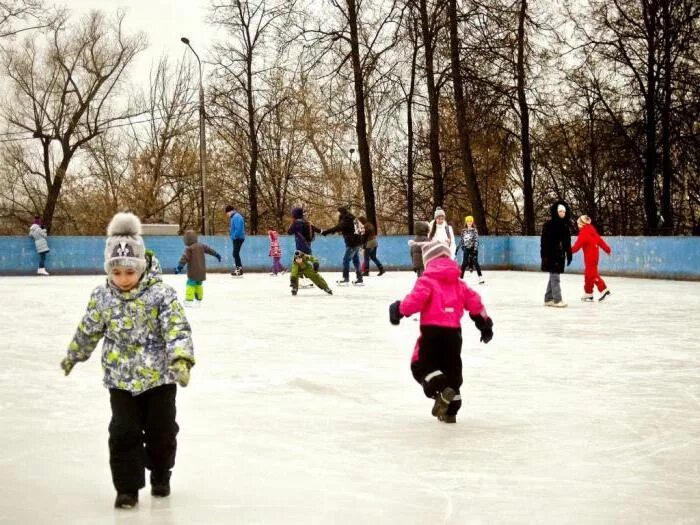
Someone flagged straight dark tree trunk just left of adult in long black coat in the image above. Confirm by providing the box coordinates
[517,0,535,235]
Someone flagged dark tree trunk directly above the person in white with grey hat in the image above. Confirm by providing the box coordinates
[420,0,445,206]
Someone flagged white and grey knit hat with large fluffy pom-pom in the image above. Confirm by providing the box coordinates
[105,213,146,274]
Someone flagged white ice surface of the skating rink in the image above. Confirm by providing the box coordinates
[0,272,700,525]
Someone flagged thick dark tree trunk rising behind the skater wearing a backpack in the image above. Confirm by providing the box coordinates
[347,0,379,225]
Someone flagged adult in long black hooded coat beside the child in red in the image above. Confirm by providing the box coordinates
[540,201,572,307]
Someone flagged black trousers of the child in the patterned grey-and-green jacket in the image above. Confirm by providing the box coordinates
[109,384,179,492]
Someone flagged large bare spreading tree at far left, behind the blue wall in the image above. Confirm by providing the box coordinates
[3,12,144,229]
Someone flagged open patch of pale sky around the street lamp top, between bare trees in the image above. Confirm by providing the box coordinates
[66,0,215,84]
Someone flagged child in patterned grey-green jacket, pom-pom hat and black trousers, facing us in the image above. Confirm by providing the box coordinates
[61,213,194,508]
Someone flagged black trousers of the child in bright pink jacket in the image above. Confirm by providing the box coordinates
[411,326,462,415]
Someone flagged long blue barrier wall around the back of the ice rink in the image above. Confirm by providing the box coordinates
[0,235,700,280]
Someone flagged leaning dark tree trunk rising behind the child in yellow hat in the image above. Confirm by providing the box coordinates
[449,0,488,235]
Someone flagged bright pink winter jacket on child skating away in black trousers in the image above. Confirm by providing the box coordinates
[399,257,486,328]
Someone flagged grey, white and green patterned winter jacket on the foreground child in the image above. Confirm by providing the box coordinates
[68,257,194,395]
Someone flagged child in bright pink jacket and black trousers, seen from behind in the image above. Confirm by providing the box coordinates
[389,241,493,423]
